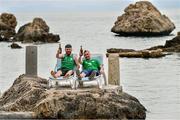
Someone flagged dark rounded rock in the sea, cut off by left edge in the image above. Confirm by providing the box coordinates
[0,13,17,41]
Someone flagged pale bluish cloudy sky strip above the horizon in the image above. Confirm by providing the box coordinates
[0,0,180,13]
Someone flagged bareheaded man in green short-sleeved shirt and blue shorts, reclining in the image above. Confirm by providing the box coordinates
[76,50,104,80]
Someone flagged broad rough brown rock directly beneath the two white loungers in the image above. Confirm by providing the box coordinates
[34,90,145,119]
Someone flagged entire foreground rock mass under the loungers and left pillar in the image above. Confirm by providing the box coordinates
[0,75,146,119]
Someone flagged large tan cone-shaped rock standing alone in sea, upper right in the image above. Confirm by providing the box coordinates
[111,1,175,36]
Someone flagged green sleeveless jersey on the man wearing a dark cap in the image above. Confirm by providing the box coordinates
[61,54,75,70]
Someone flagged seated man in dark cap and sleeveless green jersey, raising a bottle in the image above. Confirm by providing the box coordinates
[51,44,80,78]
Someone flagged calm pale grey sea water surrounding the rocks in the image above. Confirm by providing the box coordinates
[0,11,180,120]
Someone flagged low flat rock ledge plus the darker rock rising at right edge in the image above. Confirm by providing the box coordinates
[107,35,180,58]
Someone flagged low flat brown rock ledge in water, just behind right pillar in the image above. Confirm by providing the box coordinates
[107,48,166,58]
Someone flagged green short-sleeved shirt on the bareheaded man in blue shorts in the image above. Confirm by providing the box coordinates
[82,59,100,70]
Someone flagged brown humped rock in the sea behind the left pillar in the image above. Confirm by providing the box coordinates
[14,18,60,43]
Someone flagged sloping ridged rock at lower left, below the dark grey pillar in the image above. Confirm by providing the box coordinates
[0,75,48,112]
